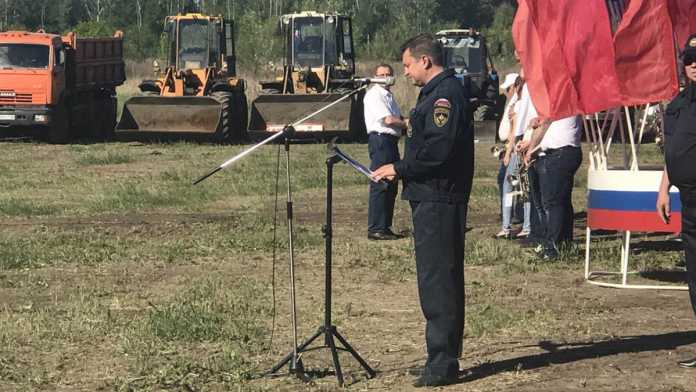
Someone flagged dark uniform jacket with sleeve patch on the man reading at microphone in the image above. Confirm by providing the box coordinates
[394,70,474,203]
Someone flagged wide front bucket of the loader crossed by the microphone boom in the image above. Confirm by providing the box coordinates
[249,94,356,133]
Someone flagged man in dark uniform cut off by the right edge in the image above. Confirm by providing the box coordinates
[657,34,696,368]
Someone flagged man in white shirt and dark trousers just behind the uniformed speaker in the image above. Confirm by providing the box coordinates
[363,64,407,240]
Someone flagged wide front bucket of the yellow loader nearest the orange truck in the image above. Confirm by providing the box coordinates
[116,96,222,134]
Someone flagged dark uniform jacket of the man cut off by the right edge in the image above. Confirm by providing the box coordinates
[664,82,696,190]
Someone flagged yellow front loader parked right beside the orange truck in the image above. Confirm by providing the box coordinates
[117,13,248,142]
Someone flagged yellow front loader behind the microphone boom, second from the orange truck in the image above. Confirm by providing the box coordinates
[249,11,365,139]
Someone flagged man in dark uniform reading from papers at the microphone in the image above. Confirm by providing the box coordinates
[374,34,474,387]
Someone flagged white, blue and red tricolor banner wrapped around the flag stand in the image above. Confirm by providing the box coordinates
[587,170,681,233]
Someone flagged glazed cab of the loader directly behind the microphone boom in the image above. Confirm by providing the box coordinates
[281,12,355,78]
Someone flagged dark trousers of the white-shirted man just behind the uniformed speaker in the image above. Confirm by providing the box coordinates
[367,132,401,233]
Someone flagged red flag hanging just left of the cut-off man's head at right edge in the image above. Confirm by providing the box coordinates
[614,0,676,106]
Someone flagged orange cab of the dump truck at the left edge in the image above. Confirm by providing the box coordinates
[0,31,66,127]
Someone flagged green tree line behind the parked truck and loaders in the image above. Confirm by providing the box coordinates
[0,0,516,69]
